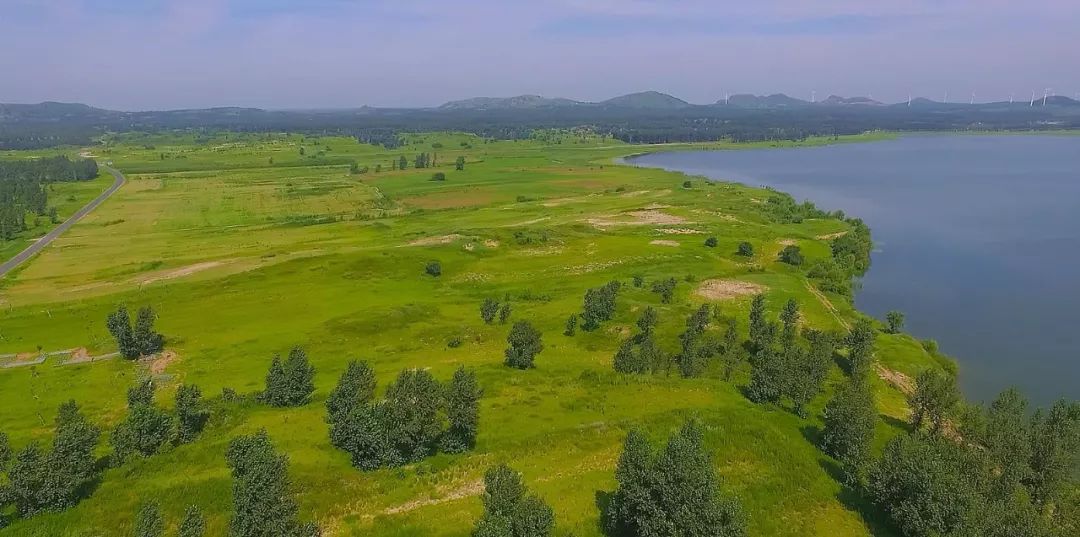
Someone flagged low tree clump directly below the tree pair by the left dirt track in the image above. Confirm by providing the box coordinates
[109,378,210,465]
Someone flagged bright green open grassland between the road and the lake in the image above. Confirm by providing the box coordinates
[0,129,935,536]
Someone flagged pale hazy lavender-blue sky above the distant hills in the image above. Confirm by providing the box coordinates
[0,0,1080,110]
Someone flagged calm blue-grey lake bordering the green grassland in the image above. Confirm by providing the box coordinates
[630,135,1080,405]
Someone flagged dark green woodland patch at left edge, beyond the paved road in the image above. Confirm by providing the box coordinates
[0,157,97,241]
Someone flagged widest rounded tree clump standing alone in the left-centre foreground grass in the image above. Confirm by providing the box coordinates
[326,362,483,470]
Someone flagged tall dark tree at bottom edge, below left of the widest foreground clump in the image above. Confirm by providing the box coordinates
[225,430,320,537]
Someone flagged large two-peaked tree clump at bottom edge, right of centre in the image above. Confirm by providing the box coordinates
[603,421,746,537]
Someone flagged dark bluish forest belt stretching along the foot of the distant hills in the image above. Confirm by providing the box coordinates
[0,98,1080,149]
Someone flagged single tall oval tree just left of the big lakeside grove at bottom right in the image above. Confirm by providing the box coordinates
[821,378,877,485]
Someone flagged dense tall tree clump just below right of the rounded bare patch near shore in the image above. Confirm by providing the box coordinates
[747,295,839,416]
